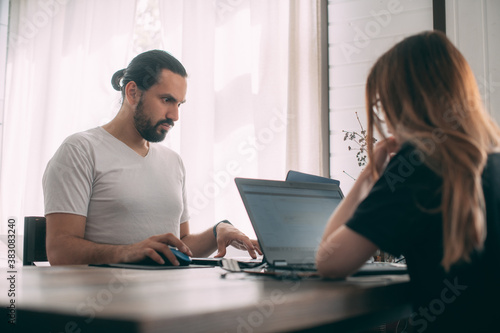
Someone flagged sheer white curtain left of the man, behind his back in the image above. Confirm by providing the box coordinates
[0,0,136,234]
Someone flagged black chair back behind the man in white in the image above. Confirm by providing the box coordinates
[23,216,48,266]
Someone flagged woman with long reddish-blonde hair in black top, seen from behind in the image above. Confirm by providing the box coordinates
[316,32,500,332]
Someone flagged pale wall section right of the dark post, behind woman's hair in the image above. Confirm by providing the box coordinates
[446,0,500,123]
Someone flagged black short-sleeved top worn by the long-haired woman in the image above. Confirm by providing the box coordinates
[347,144,500,332]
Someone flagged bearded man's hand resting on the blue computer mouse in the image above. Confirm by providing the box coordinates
[120,233,193,266]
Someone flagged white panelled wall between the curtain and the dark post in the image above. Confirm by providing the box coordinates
[328,0,432,193]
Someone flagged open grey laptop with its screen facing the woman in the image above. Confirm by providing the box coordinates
[235,178,406,275]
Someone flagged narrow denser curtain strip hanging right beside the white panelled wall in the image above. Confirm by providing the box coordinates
[287,1,329,176]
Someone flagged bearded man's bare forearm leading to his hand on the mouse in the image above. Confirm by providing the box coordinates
[47,236,127,265]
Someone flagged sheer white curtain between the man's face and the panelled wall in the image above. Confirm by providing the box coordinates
[160,0,326,239]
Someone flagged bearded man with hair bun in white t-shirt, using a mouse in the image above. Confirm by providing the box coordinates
[43,50,261,265]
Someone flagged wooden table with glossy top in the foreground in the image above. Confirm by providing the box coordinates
[0,266,411,333]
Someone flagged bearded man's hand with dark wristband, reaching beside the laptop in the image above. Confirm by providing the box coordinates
[215,223,262,259]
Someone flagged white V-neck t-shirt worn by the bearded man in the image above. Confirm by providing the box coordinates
[43,127,189,244]
